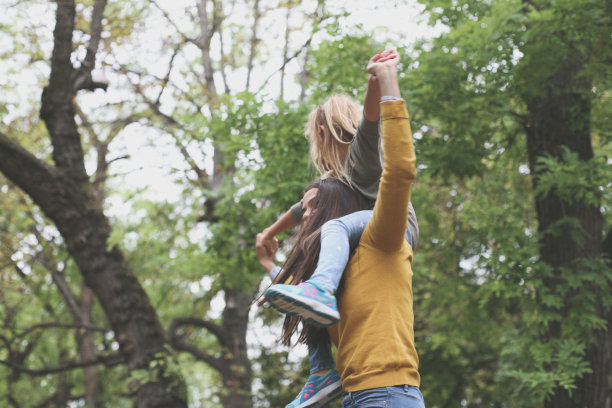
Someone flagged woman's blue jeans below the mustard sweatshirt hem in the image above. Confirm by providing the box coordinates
[342,385,425,408]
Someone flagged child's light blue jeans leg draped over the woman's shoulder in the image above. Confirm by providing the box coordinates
[307,210,414,294]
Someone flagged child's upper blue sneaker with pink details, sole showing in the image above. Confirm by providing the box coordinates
[265,282,340,327]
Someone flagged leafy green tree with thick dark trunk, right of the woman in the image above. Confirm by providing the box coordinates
[410,1,612,407]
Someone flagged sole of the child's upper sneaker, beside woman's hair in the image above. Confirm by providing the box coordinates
[265,289,340,327]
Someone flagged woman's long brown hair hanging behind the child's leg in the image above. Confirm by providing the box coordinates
[280,178,369,345]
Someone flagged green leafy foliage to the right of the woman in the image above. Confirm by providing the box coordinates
[403,1,610,407]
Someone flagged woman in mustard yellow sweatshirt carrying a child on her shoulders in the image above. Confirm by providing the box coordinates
[258,52,424,408]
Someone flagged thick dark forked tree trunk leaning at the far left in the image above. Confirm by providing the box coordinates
[0,0,187,408]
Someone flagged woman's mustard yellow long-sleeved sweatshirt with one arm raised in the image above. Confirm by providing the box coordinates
[329,100,420,391]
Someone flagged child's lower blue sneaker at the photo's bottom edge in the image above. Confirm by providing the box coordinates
[285,368,342,408]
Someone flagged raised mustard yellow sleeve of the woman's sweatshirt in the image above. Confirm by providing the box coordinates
[362,100,416,252]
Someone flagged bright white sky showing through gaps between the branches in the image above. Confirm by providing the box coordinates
[0,0,440,209]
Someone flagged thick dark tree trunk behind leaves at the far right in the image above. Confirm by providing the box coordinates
[527,57,612,408]
